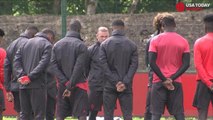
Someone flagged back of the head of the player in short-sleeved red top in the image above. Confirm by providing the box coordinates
[161,14,176,27]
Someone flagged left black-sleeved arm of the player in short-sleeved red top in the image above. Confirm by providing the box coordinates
[149,52,167,82]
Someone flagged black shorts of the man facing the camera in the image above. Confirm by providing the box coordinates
[89,90,103,111]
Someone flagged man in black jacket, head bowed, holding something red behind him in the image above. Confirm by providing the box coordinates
[13,29,55,120]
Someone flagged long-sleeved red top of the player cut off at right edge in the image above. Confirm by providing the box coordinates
[194,32,213,87]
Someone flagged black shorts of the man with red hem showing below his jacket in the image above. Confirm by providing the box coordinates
[56,85,89,119]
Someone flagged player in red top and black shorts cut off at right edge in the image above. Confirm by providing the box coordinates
[193,14,213,120]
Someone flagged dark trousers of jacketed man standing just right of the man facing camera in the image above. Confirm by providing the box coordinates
[103,90,132,120]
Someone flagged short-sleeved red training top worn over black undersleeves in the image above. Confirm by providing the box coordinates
[149,32,190,83]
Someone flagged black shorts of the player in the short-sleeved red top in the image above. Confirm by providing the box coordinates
[151,82,184,115]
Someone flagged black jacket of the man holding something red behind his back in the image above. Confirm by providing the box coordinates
[14,33,52,89]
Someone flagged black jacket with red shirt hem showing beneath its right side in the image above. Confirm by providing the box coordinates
[51,31,88,90]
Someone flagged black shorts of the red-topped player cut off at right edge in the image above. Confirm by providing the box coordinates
[193,81,213,110]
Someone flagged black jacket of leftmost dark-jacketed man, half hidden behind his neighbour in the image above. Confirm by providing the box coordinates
[4,33,29,91]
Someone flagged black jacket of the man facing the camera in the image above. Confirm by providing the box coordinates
[88,42,105,91]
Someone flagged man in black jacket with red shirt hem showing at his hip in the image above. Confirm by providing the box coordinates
[51,20,88,120]
